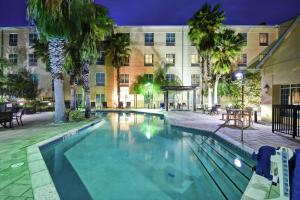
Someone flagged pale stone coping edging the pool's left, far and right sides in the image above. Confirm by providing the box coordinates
[27,109,255,200]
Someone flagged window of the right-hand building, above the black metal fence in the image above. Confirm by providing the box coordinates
[280,84,300,105]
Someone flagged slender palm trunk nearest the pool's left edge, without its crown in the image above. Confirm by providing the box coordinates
[81,61,91,118]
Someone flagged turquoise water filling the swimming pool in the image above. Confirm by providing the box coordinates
[41,113,254,200]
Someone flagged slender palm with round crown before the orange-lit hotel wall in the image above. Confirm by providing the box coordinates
[103,33,131,107]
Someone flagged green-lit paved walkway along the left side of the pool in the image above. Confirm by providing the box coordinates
[0,112,95,200]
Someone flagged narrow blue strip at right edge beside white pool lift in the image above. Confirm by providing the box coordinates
[291,149,300,200]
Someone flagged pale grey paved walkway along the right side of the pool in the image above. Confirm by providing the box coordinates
[166,112,300,150]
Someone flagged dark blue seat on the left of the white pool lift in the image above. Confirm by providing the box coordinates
[252,146,276,180]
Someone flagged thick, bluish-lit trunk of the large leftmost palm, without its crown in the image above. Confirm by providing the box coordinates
[48,38,66,123]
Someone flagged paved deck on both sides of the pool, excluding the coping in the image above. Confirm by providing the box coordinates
[0,109,300,200]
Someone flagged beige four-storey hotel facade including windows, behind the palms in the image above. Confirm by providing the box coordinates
[0,26,280,107]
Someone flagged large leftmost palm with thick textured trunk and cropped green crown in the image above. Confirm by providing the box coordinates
[27,0,90,123]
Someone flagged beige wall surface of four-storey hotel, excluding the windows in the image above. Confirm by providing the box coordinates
[1,26,278,107]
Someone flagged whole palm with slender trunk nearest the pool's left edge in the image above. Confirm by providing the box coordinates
[72,3,114,118]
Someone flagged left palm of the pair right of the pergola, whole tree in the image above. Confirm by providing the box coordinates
[188,3,225,107]
